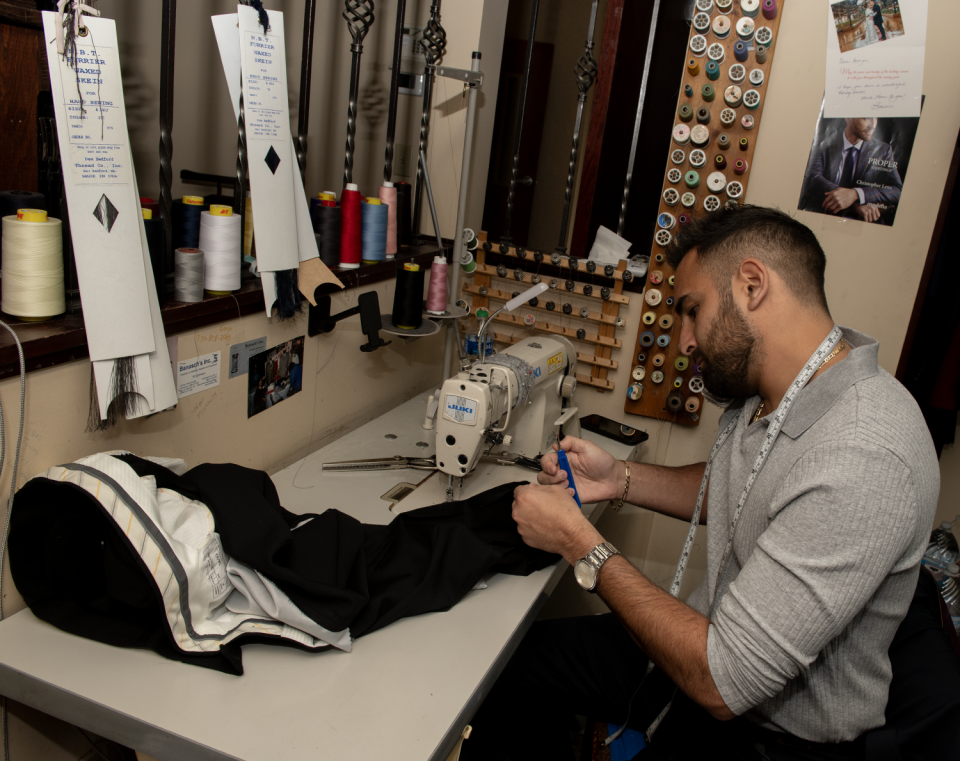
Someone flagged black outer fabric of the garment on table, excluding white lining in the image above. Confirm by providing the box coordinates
[10,455,558,674]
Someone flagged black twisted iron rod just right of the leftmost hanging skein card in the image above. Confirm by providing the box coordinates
[156,0,177,304]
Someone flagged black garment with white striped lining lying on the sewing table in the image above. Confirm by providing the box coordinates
[10,453,557,674]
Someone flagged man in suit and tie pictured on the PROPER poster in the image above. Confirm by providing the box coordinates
[800,117,903,222]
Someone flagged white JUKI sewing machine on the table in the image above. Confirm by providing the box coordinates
[436,336,580,500]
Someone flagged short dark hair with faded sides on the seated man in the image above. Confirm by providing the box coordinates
[667,205,830,313]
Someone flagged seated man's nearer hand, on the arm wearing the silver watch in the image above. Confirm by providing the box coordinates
[513,484,603,565]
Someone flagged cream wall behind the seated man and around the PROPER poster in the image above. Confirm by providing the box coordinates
[547,0,960,615]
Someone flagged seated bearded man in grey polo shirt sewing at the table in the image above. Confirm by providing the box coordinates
[464,206,939,761]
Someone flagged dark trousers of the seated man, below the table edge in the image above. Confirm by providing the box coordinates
[461,614,862,761]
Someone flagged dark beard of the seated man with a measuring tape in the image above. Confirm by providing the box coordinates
[693,289,762,404]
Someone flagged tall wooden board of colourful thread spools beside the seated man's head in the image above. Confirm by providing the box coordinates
[622,0,784,425]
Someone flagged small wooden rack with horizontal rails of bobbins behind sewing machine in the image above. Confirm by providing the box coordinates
[460,232,630,391]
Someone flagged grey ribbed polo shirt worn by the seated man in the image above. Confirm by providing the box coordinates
[689,329,939,742]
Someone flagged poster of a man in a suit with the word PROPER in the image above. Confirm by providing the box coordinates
[799,97,920,225]
